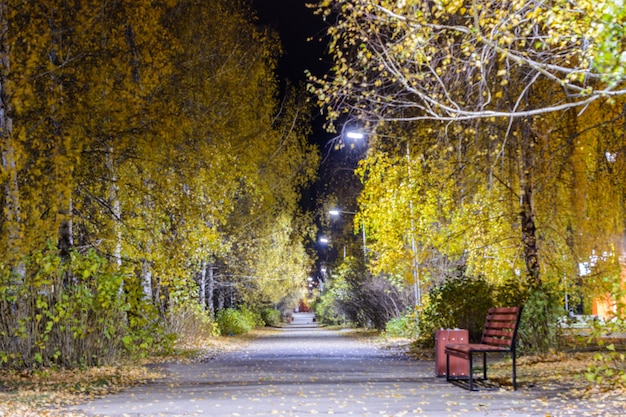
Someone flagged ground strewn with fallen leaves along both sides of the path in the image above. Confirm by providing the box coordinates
[0,332,626,417]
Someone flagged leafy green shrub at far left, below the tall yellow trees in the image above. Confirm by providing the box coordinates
[0,249,129,368]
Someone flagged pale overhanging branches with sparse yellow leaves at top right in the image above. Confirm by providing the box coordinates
[312,0,626,120]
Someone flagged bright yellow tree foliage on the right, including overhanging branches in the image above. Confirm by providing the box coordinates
[309,0,626,318]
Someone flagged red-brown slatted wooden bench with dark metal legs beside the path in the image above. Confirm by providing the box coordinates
[445,307,522,391]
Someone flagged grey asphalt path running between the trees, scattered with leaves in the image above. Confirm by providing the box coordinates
[71,313,612,417]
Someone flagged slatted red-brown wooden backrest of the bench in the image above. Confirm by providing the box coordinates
[481,307,522,350]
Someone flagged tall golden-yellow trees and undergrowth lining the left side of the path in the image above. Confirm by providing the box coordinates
[0,0,319,367]
